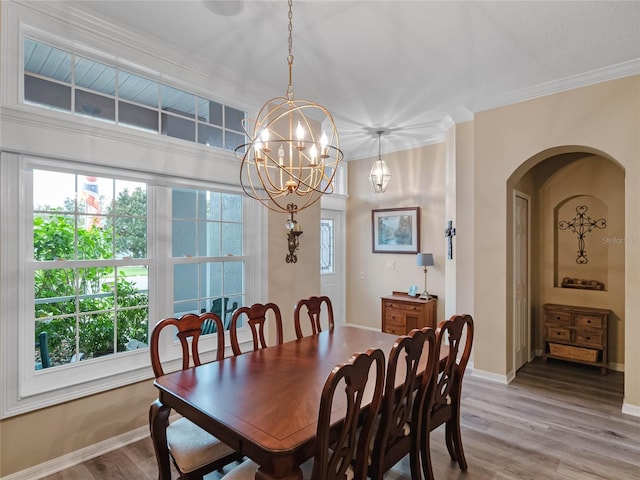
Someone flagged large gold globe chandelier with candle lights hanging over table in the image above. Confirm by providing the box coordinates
[235,0,343,232]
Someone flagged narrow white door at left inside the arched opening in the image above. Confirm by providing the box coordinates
[513,192,531,371]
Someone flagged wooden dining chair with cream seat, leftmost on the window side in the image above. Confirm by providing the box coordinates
[149,312,242,480]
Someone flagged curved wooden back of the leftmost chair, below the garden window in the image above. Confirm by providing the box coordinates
[149,312,224,378]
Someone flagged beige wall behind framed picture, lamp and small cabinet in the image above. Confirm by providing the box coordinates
[346,144,446,329]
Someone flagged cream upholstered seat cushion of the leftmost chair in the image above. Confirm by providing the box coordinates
[167,418,234,473]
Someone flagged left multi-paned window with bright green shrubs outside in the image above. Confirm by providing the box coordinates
[32,169,149,369]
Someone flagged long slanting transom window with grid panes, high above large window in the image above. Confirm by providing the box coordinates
[24,38,246,155]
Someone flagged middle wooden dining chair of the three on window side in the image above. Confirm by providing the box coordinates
[229,303,284,355]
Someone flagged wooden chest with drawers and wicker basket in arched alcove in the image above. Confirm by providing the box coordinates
[544,303,611,375]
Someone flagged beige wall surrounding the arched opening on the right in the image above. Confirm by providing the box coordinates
[473,76,640,411]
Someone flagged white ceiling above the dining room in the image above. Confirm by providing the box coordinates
[62,0,640,159]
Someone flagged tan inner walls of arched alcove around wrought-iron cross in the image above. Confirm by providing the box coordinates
[507,146,625,375]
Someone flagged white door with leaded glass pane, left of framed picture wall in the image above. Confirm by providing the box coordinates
[320,210,345,325]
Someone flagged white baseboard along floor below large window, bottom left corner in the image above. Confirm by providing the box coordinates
[0,425,149,480]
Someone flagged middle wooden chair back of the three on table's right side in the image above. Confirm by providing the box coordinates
[368,327,438,480]
